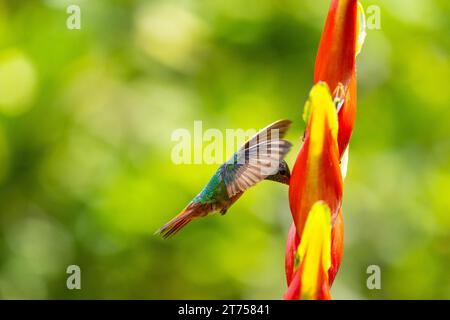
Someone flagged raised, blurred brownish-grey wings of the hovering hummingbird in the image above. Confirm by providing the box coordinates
[221,120,292,198]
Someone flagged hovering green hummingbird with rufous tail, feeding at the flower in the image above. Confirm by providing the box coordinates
[156,120,292,238]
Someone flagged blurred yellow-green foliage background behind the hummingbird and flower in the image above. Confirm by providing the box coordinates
[0,0,450,299]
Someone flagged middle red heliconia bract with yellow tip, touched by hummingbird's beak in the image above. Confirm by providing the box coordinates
[289,82,342,239]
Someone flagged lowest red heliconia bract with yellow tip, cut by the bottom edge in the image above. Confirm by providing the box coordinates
[284,201,331,300]
